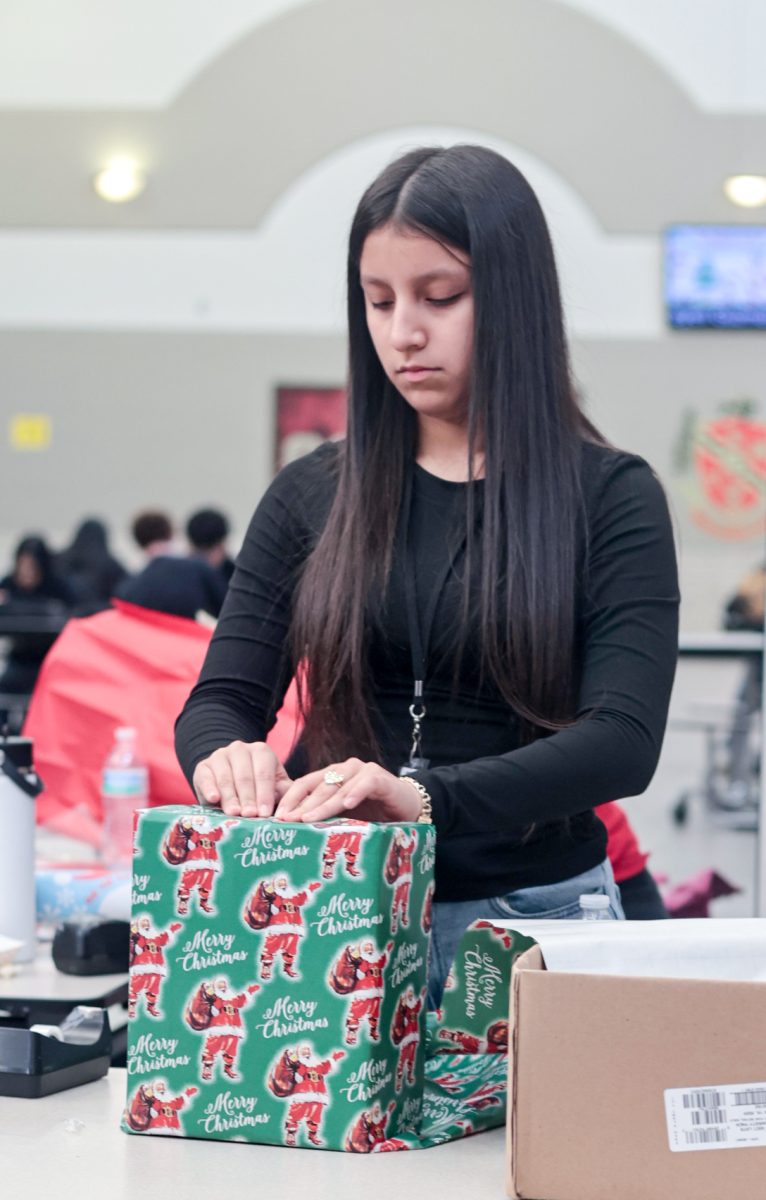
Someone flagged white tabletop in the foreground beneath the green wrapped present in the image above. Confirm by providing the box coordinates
[0,1068,505,1200]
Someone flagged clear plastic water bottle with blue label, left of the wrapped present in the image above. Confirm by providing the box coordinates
[101,726,149,866]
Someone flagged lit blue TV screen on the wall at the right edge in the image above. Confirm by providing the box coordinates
[665,226,766,329]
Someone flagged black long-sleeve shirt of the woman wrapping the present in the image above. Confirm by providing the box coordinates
[176,443,678,900]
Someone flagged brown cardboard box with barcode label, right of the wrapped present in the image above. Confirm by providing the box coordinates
[507,936,766,1200]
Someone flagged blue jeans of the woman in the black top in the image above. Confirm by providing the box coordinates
[429,858,626,1008]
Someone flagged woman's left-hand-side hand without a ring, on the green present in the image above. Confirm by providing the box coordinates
[192,742,292,817]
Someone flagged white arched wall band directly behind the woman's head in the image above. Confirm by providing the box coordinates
[0,126,663,337]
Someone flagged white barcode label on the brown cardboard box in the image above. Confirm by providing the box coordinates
[665,1084,766,1151]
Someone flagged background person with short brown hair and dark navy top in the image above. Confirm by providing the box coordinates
[116,512,226,620]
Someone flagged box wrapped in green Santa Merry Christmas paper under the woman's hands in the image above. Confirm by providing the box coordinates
[122,808,436,1151]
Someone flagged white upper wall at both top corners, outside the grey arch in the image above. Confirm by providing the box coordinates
[0,0,766,113]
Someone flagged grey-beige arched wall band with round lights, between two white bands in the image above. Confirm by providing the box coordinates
[0,0,766,233]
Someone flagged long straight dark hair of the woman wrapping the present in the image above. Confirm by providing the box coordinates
[293,145,603,766]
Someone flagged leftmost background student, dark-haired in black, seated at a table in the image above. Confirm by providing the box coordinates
[0,535,74,695]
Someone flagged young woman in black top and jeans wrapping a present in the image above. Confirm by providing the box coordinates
[176,146,678,1003]
